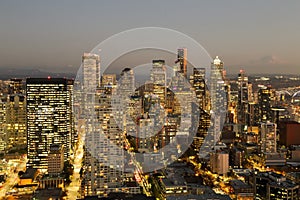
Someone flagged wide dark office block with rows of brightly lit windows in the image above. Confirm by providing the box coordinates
[26,77,72,171]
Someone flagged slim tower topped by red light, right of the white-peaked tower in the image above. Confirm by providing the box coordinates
[237,70,249,125]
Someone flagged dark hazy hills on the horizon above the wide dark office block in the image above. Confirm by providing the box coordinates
[0,68,76,80]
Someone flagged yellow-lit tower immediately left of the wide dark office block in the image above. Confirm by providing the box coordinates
[6,94,27,148]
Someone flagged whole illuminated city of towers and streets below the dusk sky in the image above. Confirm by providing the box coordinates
[0,48,300,200]
